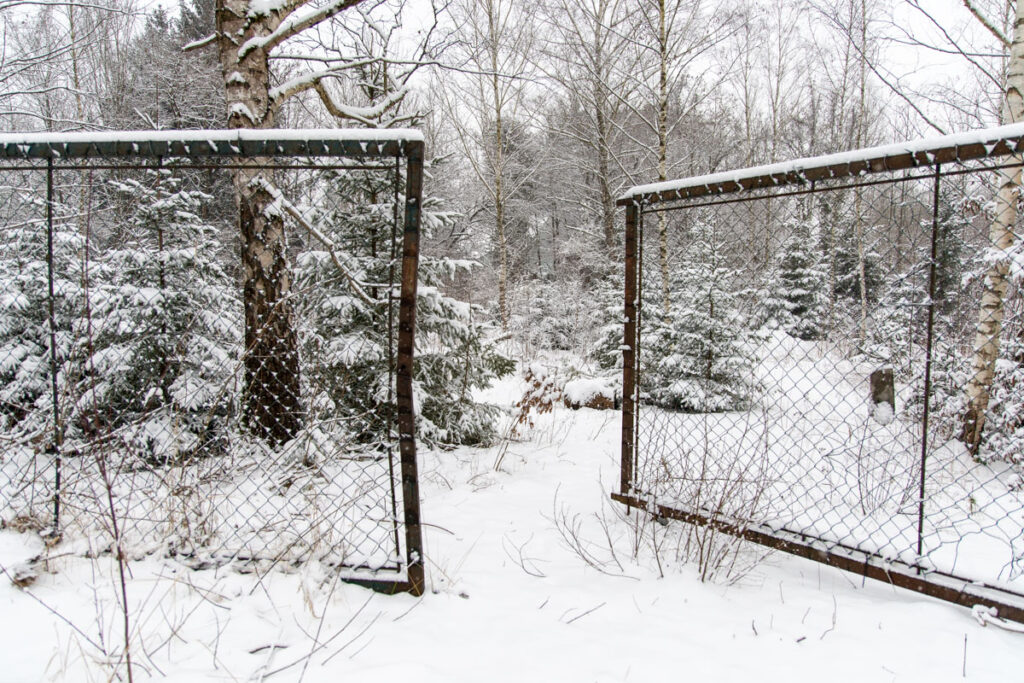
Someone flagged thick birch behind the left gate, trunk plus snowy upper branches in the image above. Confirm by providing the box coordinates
[192,0,395,443]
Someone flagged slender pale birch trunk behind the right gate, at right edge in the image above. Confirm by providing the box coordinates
[962,2,1024,455]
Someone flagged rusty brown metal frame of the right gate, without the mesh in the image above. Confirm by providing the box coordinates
[610,124,1024,623]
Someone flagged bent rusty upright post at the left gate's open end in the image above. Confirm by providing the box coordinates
[395,141,424,595]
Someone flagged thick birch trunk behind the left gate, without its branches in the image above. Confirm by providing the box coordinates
[216,0,303,444]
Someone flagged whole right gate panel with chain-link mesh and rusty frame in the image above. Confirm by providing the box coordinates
[615,127,1024,621]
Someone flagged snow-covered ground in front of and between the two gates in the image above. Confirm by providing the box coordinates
[0,370,1024,683]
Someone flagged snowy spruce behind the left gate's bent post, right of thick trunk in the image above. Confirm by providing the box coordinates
[296,158,512,447]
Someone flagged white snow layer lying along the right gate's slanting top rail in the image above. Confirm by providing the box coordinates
[618,123,1024,200]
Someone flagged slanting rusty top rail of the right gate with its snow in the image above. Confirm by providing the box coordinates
[616,123,1024,206]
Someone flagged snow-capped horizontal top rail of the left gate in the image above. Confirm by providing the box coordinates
[0,128,423,159]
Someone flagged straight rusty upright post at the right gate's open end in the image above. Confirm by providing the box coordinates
[618,204,640,496]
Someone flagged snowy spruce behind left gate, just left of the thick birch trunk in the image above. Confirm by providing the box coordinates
[73,170,241,461]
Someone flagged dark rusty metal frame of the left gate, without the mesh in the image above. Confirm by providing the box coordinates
[0,129,425,596]
